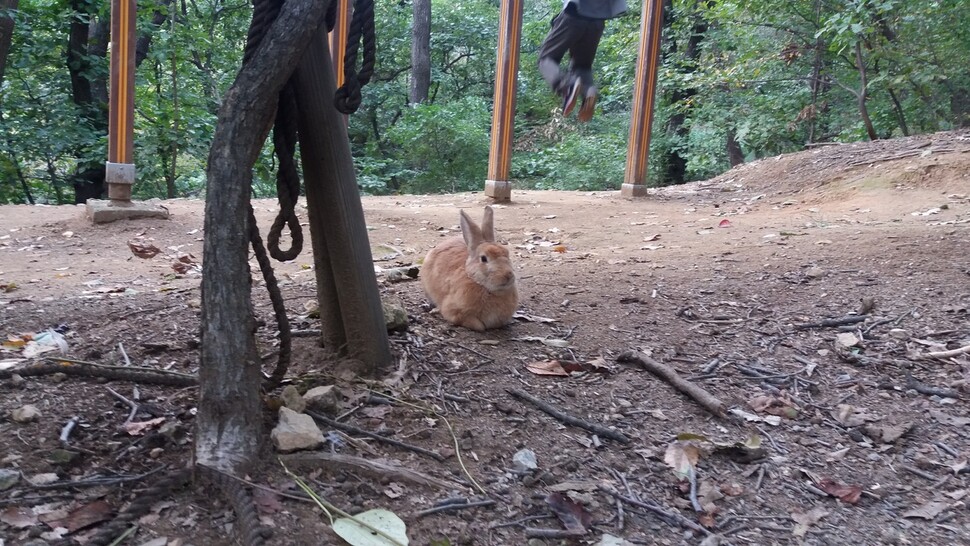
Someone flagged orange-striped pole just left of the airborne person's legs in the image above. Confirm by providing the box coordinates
[485,0,522,201]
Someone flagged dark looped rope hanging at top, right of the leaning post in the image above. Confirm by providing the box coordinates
[332,0,377,114]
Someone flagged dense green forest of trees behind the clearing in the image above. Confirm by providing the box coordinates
[0,0,970,204]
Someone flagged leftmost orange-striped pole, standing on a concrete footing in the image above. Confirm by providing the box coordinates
[105,0,135,201]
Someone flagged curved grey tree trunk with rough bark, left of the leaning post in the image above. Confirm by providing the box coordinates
[195,0,328,474]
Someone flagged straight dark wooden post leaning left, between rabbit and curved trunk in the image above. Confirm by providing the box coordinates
[293,19,391,376]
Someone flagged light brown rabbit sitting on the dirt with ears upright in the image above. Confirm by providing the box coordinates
[421,207,519,331]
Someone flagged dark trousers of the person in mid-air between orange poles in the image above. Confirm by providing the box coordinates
[539,11,606,94]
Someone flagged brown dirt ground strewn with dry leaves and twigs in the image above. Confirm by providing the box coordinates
[0,132,970,545]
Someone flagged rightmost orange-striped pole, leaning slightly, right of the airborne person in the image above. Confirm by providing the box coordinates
[620,0,663,197]
